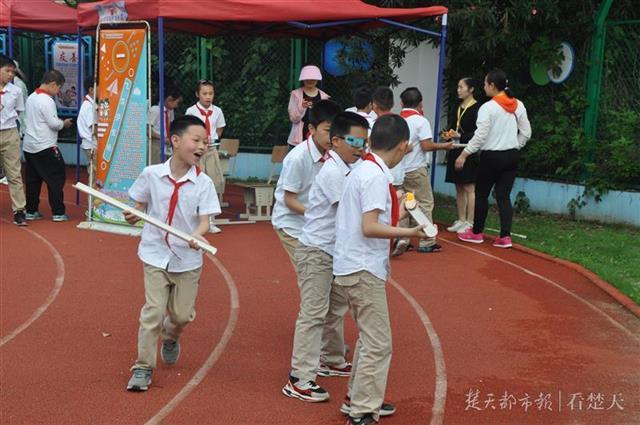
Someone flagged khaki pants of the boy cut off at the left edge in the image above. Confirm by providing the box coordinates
[0,128,27,212]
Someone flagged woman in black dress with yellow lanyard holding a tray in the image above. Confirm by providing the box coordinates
[445,77,480,232]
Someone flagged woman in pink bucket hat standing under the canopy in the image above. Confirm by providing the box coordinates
[287,65,330,150]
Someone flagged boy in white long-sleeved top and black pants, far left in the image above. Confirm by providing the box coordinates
[22,69,72,221]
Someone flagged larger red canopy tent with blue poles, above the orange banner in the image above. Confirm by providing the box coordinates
[78,0,448,185]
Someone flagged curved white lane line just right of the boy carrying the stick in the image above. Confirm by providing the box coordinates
[145,254,240,425]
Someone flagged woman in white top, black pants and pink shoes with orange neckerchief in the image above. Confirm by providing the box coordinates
[455,69,531,248]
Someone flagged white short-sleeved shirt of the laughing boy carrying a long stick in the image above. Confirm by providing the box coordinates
[129,159,220,272]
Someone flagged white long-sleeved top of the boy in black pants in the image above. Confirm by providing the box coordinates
[22,90,64,153]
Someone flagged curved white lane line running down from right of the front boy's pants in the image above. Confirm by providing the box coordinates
[389,278,447,425]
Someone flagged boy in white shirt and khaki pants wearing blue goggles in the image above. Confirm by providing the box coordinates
[282,112,369,402]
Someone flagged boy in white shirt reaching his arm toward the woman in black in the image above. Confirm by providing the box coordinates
[393,87,453,256]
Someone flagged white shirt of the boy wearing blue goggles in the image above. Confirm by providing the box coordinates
[300,152,351,256]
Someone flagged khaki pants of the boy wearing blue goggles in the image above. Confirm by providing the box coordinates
[291,244,349,382]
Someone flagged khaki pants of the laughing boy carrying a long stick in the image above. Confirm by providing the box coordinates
[132,264,202,369]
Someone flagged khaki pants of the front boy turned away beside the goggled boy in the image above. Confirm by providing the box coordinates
[333,271,392,419]
